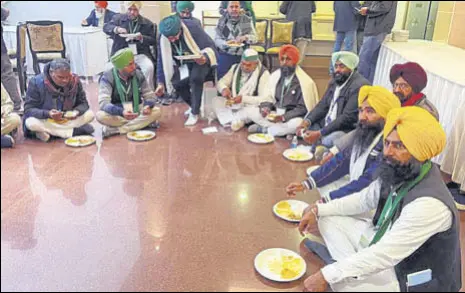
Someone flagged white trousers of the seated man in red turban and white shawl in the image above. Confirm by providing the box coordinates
[246,107,303,136]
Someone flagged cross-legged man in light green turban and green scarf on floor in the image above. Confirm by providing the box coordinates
[97,48,161,138]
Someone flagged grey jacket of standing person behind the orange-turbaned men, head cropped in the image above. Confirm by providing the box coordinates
[279,1,316,39]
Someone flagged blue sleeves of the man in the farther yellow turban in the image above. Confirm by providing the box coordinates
[306,138,383,200]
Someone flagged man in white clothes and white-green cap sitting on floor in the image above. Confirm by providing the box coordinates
[213,49,273,131]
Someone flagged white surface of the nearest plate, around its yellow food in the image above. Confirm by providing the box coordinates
[254,248,307,282]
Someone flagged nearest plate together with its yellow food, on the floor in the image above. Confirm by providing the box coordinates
[254,248,307,282]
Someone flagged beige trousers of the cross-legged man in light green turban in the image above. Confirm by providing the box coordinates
[97,107,161,134]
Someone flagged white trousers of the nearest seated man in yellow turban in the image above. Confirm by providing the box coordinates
[318,216,400,292]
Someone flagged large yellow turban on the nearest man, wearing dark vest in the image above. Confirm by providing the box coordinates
[384,106,446,162]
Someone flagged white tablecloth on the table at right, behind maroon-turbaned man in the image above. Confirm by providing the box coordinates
[374,40,465,164]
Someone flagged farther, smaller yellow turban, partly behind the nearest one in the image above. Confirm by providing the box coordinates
[358,85,401,119]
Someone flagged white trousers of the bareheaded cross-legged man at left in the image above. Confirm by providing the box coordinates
[25,110,94,138]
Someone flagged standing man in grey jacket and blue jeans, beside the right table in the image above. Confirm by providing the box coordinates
[359,1,397,83]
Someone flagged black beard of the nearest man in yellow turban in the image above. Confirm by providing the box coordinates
[375,156,423,187]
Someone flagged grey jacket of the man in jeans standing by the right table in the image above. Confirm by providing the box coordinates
[365,1,397,36]
